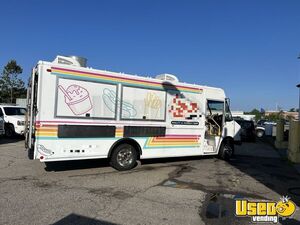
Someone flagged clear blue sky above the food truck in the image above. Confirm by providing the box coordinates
[0,0,300,110]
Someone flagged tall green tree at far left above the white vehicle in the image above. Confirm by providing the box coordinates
[0,60,26,103]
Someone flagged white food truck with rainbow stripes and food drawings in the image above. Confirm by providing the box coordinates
[26,56,240,170]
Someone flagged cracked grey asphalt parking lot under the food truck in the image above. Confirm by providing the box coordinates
[0,138,300,225]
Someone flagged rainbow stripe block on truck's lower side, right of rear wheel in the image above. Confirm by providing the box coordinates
[144,135,200,148]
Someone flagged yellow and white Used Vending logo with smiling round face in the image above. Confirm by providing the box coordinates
[235,196,296,223]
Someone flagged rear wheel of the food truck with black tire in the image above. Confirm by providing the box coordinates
[110,144,137,171]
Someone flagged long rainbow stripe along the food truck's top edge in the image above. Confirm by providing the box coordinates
[51,67,203,93]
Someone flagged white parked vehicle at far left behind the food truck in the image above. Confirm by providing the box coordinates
[0,105,26,137]
